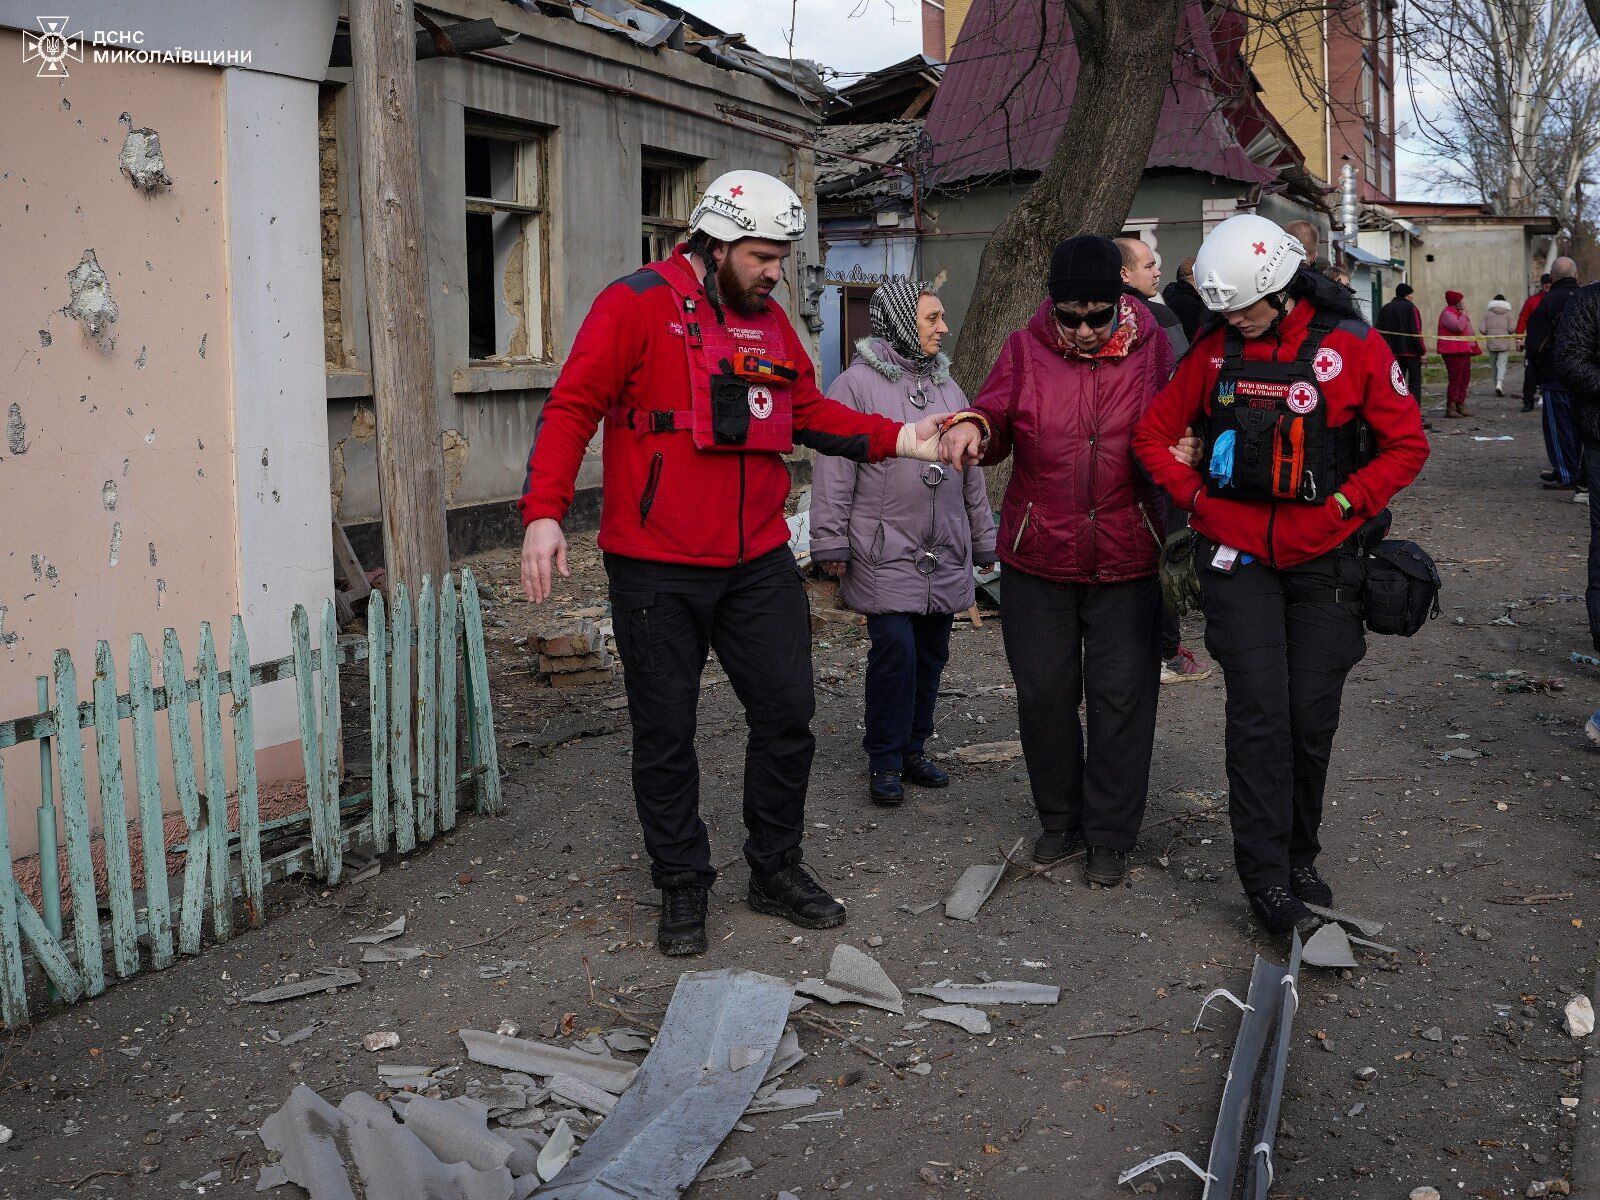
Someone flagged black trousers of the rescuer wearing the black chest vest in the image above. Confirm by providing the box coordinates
[1195,542,1366,891]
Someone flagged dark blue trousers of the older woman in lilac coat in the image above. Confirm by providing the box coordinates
[861,613,955,771]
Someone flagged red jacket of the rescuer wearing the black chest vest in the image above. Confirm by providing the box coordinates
[1133,299,1427,566]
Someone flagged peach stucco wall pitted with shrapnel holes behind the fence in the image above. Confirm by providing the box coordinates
[0,30,238,854]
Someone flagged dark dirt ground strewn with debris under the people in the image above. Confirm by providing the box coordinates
[0,369,1600,1200]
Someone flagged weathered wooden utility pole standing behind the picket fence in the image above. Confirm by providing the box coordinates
[349,0,450,595]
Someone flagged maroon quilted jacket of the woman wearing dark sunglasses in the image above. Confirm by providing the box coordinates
[971,296,1173,584]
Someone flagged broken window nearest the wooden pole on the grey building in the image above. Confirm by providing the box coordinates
[466,123,550,369]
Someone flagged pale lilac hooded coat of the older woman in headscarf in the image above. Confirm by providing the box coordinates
[811,338,995,613]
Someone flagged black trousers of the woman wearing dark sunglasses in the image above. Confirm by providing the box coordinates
[1000,566,1165,851]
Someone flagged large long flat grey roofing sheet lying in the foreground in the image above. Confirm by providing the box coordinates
[536,970,792,1200]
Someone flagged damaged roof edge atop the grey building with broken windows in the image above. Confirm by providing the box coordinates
[506,0,834,104]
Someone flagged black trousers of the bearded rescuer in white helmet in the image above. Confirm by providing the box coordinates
[605,546,816,886]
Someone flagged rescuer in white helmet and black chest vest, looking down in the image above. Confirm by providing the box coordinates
[1133,216,1427,936]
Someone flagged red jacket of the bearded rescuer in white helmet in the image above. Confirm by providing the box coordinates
[520,246,901,566]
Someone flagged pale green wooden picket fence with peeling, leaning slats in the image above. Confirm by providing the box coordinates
[0,570,502,1029]
